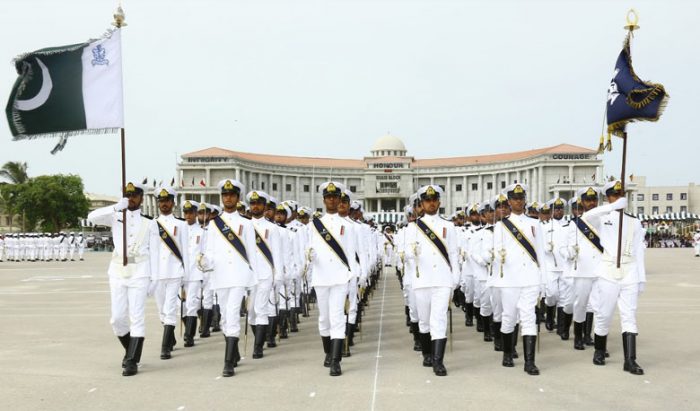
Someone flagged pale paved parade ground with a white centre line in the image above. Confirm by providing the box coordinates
[0,249,700,411]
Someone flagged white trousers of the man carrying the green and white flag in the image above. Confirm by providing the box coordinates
[109,277,149,337]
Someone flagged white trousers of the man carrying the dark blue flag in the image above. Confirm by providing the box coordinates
[591,278,639,336]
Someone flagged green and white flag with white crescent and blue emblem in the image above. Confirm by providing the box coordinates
[5,29,124,153]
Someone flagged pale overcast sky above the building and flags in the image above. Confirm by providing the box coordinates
[0,0,700,195]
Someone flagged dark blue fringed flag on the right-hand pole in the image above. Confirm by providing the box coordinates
[606,35,668,136]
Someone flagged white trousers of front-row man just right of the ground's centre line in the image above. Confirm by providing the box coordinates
[415,287,452,340]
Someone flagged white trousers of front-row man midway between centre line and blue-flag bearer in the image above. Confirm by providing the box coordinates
[501,285,540,336]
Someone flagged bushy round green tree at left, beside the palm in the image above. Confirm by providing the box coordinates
[17,174,90,232]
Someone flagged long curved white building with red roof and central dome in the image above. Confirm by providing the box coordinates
[145,135,603,219]
